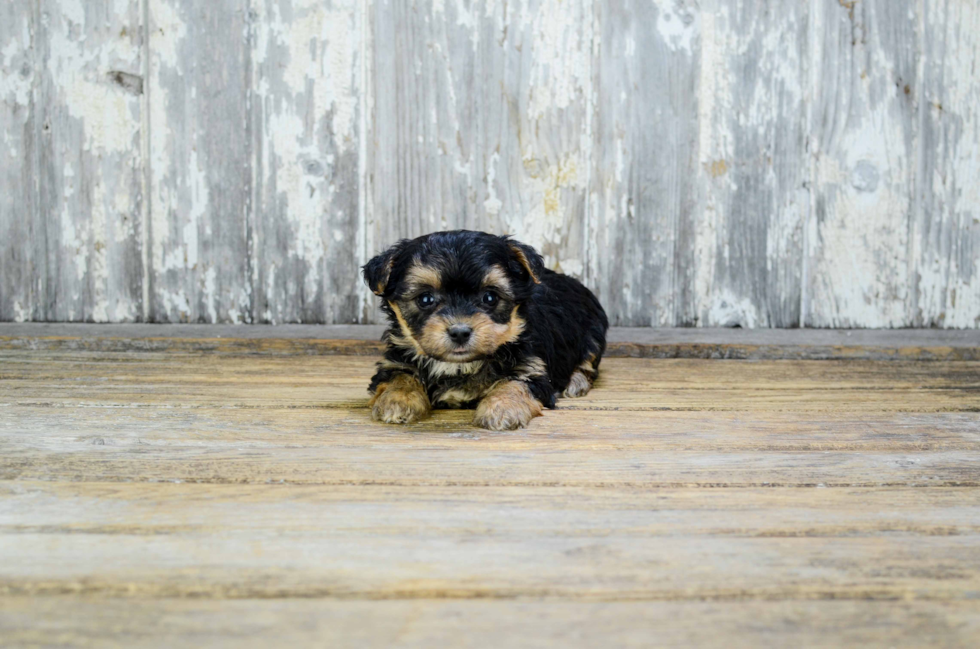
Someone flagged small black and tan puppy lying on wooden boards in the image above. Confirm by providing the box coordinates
[363,230,609,430]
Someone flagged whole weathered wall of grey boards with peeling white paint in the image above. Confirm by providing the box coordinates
[0,0,980,327]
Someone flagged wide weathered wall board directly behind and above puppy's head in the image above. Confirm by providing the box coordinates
[365,0,592,311]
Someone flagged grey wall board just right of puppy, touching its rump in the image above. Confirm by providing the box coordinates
[588,0,701,326]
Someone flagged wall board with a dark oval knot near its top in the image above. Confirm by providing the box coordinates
[36,0,143,322]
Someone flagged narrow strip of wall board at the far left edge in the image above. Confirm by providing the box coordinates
[0,2,38,322]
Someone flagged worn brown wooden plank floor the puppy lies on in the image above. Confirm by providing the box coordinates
[0,331,980,647]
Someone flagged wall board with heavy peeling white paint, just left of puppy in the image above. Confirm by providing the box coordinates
[249,0,364,324]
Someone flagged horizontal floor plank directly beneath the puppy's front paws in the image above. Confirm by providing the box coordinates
[0,404,980,488]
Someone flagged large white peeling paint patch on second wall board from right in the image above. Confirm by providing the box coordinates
[808,4,915,327]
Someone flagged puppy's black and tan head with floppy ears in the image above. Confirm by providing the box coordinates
[363,230,544,363]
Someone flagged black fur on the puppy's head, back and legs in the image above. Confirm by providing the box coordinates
[363,230,609,418]
